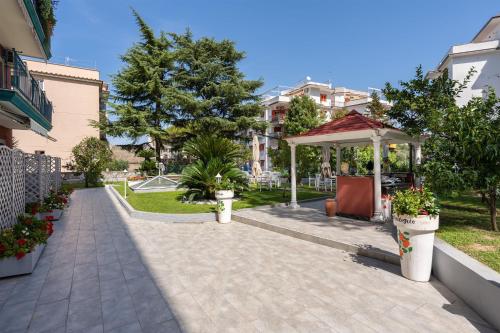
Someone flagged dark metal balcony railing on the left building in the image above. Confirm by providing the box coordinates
[0,50,52,123]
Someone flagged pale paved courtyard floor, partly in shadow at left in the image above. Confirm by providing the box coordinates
[0,188,493,332]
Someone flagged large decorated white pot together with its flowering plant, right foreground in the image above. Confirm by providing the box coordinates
[392,188,439,282]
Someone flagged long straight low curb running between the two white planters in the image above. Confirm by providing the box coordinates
[233,213,400,266]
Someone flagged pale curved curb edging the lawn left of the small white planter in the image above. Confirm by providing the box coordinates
[106,185,216,223]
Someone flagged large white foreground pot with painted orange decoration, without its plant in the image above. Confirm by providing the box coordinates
[393,215,439,282]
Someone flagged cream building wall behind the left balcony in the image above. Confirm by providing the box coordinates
[13,61,108,166]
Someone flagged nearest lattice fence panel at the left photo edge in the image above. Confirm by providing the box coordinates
[0,146,25,229]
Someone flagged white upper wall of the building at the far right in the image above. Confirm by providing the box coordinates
[448,50,500,105]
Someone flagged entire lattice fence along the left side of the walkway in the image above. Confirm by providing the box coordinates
[0,146,61,229]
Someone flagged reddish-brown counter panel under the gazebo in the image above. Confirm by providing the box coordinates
[337,176,375,219]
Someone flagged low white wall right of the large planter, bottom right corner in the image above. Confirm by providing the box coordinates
[432,238,500,331]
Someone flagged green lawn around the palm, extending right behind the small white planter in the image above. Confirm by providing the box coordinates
[114,184,332,214]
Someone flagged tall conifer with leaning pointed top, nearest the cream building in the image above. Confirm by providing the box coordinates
[92,10,179,162]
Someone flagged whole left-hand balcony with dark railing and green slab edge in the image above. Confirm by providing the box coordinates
[0,50,52,131]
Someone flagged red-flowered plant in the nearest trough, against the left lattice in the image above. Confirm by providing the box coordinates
[0,214,53,278]
